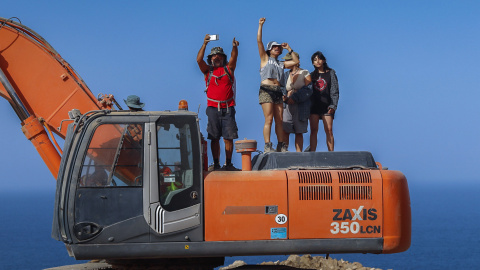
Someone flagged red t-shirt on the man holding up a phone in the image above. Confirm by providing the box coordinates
[205,67,235,108]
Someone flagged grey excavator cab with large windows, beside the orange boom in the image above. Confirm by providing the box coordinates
[53,111,204,259]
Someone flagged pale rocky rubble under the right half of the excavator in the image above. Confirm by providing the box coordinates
[220,255,390,270]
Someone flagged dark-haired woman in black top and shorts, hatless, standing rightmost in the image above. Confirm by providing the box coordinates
[309,51,339,152]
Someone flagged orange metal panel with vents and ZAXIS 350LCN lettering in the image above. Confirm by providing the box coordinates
[287,170,383,239]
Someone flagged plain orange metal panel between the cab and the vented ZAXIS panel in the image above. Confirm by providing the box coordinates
[204,171,289,241]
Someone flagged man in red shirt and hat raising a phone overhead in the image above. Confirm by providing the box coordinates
[197,34,239,171]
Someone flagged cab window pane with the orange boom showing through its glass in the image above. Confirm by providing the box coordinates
[79,124,143,187]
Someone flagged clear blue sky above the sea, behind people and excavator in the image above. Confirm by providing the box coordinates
[0,1,480,190]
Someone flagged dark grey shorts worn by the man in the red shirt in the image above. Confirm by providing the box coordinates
[206,107,238,140]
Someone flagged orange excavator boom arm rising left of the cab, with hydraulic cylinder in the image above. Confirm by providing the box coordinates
[0,17,114,177]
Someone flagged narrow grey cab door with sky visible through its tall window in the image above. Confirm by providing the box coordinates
[145,114,204,242]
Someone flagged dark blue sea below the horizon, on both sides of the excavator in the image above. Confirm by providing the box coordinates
[0,181,480,270]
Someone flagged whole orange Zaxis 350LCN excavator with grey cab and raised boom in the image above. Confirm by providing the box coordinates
[0,18,411,267]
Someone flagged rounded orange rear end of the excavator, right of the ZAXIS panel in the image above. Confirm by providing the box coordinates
[381,170,412,253]
